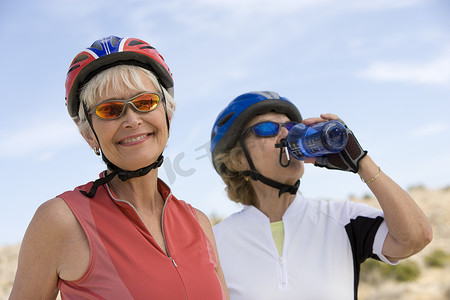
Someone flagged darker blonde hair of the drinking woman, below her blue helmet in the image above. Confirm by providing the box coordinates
[214,142,256,205]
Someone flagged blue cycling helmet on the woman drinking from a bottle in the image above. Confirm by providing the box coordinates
[211,91,302,174]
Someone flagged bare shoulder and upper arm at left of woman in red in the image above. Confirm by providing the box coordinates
[11,198,89,299]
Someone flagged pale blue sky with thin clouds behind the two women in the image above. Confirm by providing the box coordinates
[0,0,450,245]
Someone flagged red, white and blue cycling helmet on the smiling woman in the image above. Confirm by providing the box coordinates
[66,36,173,120]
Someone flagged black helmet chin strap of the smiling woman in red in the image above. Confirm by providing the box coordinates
[80,92,170,198]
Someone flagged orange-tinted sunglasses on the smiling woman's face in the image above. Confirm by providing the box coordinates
[91,92,161,120]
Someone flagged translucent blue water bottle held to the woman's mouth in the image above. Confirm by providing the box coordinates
[286,121,348,160]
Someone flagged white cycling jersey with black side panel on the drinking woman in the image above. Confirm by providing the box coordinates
[214,194,390,300]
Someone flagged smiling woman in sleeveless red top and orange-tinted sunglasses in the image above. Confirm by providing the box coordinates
[10,36,228,300]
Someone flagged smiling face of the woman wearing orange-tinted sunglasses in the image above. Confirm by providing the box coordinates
[87,72,169,171]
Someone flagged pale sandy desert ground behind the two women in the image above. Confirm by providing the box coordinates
[0,187,450,300]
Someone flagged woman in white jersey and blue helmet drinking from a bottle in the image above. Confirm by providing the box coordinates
[211,92,432,300]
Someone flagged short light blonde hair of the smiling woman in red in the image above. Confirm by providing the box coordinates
[77,65,176,134]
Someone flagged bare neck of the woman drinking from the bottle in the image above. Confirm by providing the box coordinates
[252,181,295,222]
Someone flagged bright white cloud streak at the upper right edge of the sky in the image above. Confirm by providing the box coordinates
[359,51,450,85]
